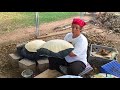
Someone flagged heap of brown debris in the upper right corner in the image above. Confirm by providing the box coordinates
[89,13,120,33]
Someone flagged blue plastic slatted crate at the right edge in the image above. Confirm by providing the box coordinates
[100,60,120,77]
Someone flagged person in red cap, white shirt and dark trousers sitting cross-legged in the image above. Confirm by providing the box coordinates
[48,18,88,75]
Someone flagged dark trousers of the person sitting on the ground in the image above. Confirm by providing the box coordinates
[48,57,86,75]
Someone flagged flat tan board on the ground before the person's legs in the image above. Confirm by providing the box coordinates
[34,69,62,78]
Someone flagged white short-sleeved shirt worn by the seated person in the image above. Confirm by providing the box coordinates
[64,33,88,65]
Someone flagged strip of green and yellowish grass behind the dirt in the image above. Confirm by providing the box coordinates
[0,12,80,34]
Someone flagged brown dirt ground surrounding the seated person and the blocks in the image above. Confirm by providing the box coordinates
[0,16,120,78]
